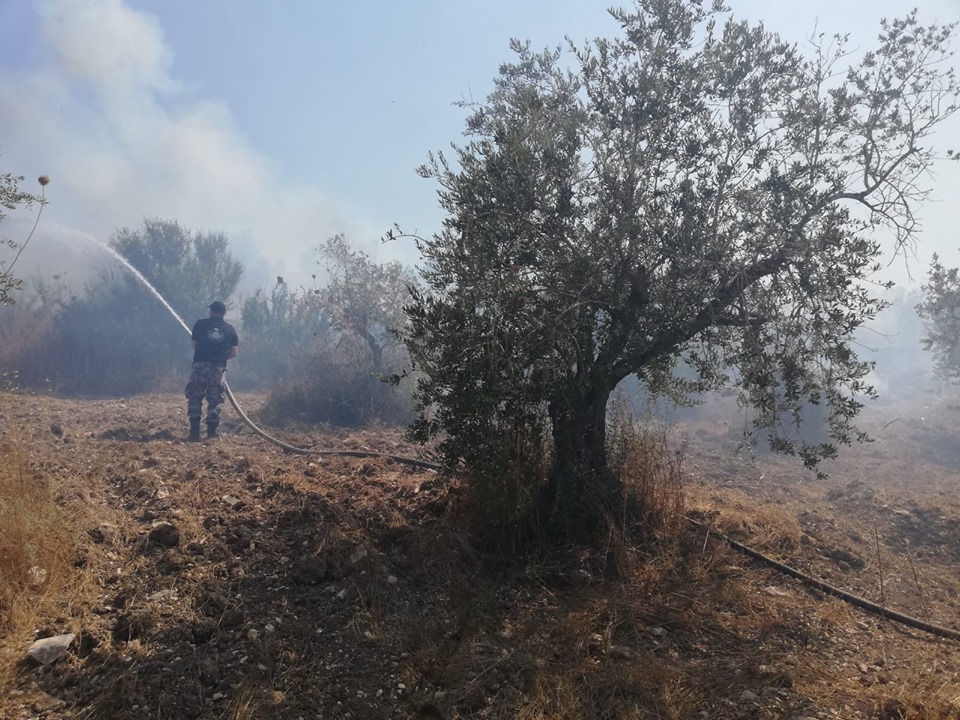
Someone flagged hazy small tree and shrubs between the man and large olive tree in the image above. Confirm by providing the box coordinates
[243,235,416,426]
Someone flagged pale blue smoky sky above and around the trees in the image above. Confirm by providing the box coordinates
[0,0,960,294]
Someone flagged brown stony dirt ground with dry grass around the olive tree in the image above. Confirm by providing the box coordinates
[0,394,960,720]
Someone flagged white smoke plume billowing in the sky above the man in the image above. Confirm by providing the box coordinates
[0,0,385,292]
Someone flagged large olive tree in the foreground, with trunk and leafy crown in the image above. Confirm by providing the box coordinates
[405,0,958,532]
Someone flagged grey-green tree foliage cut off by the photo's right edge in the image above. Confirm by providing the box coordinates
[917,255,960,383]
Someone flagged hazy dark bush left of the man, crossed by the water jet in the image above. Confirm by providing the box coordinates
[21,219,243,395]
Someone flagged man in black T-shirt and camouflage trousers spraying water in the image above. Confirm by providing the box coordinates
[186,300,240,442]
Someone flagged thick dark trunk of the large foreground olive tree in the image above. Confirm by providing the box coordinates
[539,383,620,538]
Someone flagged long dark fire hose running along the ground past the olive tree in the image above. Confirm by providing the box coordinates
[224,382,960,641]
